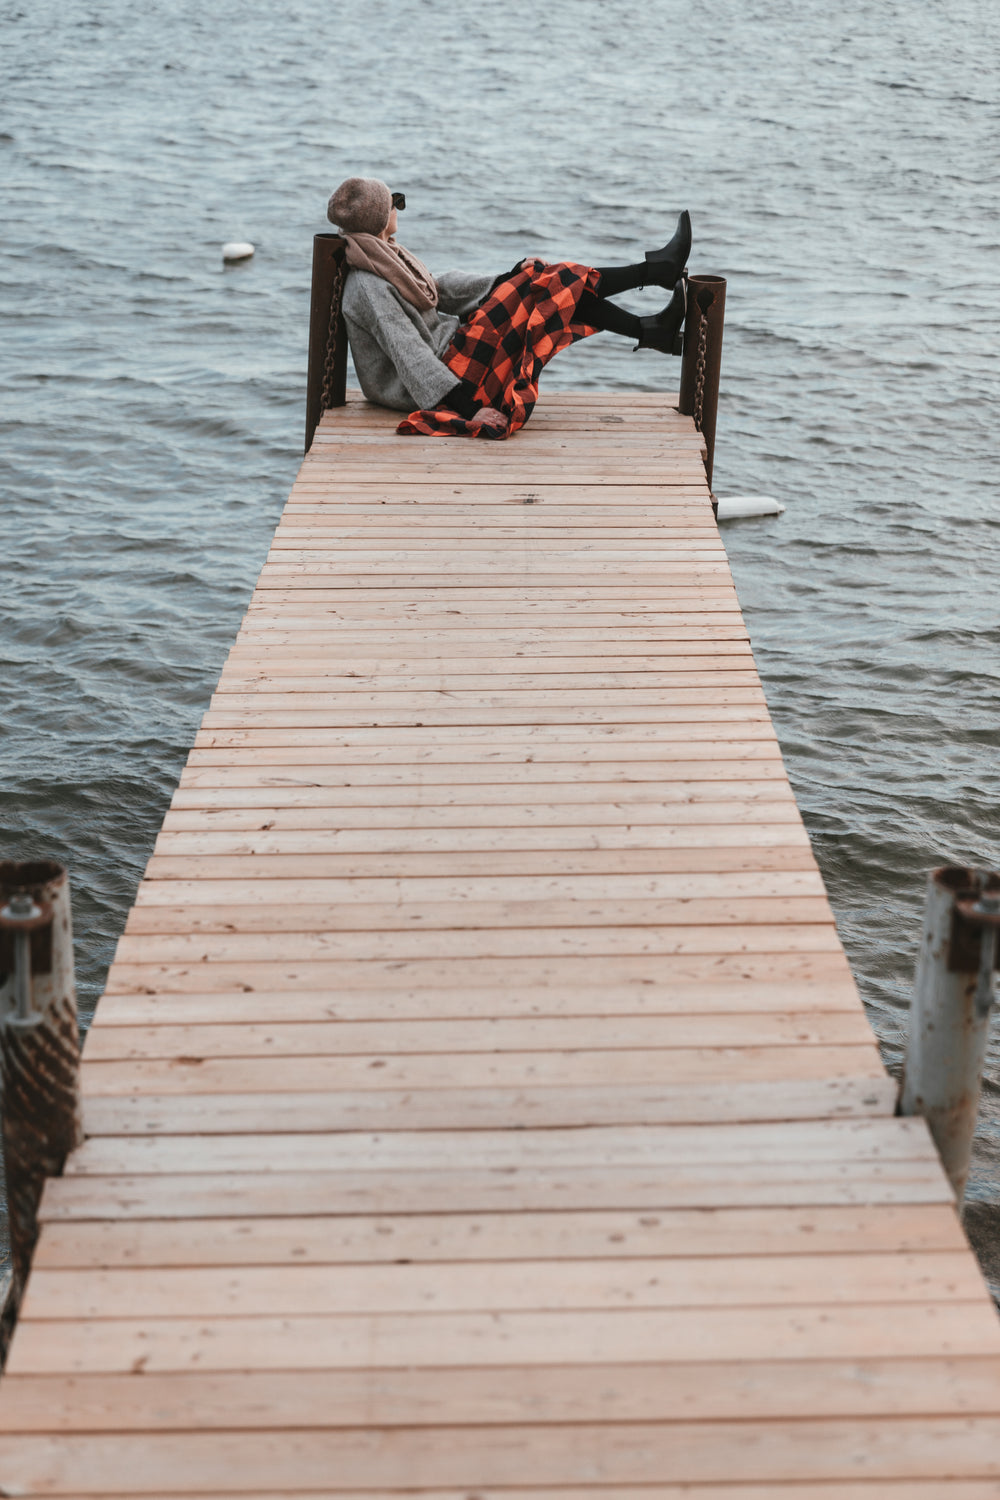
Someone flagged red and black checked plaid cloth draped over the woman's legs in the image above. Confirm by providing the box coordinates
[396,261,600,438]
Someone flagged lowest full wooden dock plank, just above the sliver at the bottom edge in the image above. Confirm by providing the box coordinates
[0,1416,1000,1500]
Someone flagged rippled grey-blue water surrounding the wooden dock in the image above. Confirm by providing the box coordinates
[0,0,1000,1272]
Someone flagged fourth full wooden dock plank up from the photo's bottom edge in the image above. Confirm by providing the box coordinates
[19,1250,983,1320]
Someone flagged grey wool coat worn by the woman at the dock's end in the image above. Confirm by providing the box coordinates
[343,269,493,411]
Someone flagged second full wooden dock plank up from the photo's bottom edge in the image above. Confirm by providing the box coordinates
[0,1356,1000,1434]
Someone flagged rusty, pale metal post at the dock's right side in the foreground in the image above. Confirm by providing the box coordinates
[900,866,1000,1208]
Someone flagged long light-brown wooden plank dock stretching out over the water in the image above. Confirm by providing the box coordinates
[0,393,1000,1500]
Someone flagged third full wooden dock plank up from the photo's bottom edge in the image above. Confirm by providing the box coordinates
[7,1301,1000,1374]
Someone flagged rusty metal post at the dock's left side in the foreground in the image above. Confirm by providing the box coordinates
[0,860,82,1358]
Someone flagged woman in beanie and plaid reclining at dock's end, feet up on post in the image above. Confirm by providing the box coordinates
[327,177,691,438]
